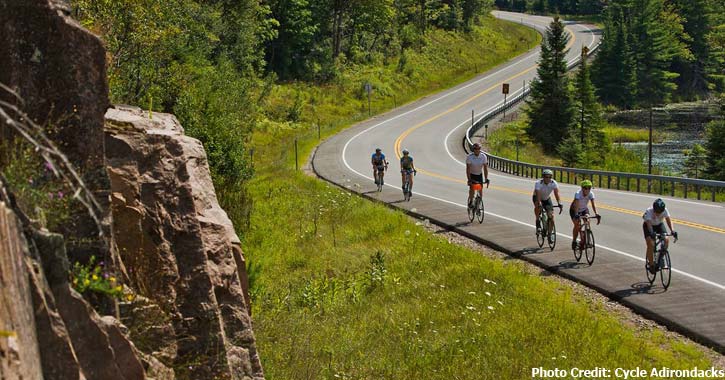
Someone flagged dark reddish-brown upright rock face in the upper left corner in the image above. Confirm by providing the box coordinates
[0,0,109,259]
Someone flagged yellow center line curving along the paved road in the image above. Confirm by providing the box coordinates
[394,23,725,234]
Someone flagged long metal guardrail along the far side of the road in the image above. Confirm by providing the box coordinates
[463,43,725,202]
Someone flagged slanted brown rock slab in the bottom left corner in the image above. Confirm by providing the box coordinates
[0,182,150,380]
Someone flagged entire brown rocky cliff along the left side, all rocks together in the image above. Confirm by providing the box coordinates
[0,0,263,380]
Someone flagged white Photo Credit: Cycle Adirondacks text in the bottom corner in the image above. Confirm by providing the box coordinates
[531,367,725,379]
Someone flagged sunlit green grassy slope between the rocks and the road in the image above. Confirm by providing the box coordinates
[235,20,708,379]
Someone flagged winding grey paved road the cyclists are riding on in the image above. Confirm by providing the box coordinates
[313,12,725,352]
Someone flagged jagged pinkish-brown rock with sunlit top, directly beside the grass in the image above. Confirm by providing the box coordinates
[106,106,263,379]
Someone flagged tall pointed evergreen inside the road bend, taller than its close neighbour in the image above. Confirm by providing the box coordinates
[526,17,574,152]
